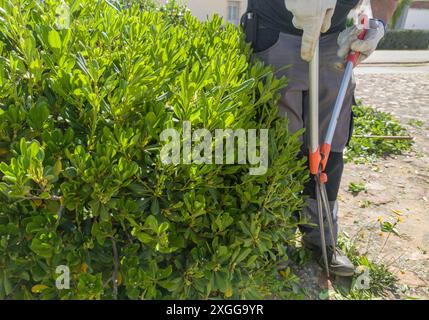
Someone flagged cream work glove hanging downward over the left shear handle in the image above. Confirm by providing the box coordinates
[285,0,337,61]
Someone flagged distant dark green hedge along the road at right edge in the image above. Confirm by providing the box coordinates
[378,30,429,50]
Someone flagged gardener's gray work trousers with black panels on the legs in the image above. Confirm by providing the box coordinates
[256,33,356,246]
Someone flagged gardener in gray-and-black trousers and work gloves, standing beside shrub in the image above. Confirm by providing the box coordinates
[242,0,397,276]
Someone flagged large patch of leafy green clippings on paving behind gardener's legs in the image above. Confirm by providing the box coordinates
[345,101,413,163]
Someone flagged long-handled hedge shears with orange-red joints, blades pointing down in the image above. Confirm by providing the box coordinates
[308,15,369,277]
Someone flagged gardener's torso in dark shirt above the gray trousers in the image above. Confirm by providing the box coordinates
[249,0,360,35]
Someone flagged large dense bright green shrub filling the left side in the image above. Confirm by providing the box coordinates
[0,0,307,299]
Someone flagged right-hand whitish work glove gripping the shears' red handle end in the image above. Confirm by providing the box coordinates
[338,19,385,63]
